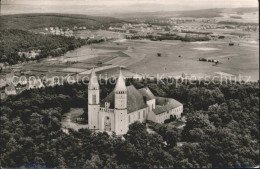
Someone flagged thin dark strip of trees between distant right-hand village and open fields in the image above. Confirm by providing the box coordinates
[126,34,210,42]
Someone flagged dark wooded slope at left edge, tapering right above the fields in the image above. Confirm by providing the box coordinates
[0,29,102,65]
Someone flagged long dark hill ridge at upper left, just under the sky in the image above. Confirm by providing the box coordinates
[0,14,126,30]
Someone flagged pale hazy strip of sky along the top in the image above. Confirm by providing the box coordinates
[1,0,258,15]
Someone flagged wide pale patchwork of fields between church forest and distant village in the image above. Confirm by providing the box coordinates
[15,32,259,81]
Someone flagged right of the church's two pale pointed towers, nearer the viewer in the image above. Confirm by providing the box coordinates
[115,69,128,135]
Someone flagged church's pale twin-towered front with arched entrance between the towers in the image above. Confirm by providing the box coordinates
[88,69,128,135]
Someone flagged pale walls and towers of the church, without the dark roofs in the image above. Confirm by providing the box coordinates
[88,70,183,135]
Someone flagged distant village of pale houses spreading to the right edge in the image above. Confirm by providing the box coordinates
[108,18,259,37]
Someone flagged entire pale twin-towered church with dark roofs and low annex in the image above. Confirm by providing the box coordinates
[88,69,183,135]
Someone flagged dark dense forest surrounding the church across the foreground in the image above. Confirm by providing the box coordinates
[1,79,259,168]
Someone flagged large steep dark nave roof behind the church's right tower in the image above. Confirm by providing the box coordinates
[101,85,147,113]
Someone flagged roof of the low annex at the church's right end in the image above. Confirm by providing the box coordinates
[153,97,182,115]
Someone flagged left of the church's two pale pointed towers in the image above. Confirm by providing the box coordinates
[88,68,100,129]
